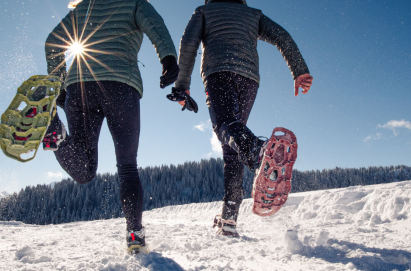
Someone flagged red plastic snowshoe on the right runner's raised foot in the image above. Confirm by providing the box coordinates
[252,128,298,216]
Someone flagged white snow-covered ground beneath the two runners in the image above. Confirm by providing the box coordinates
[0,181,411,271]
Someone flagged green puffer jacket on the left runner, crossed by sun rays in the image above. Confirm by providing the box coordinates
[46,0,177,96]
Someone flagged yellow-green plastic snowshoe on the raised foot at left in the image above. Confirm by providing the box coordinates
[0,75,61,162]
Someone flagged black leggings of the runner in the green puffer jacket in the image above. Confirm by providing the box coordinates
[53,81,143,231]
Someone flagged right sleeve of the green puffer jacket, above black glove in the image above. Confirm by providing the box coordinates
[135,0,177,61]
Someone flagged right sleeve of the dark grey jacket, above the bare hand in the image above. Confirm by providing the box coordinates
[258,15,310,79]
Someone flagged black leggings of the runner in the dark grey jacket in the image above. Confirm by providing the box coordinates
[205,72,258,205]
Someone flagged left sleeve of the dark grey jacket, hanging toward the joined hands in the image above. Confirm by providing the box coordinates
[176,8,204,90]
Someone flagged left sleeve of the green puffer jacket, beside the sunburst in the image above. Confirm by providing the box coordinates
[45,12,74,87]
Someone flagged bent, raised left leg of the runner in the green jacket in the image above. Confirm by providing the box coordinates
[53,82,104,184]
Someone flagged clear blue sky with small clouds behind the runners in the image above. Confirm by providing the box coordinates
[0,0,411,192]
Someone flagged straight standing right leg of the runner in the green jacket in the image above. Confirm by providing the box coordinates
[101,81,144,231]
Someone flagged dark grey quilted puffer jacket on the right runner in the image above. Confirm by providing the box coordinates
[176,0,309,89]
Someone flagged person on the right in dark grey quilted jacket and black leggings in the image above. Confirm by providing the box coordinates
[175,0,313,236]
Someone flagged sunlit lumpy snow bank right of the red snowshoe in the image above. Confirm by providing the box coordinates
[293,181,411,226]
